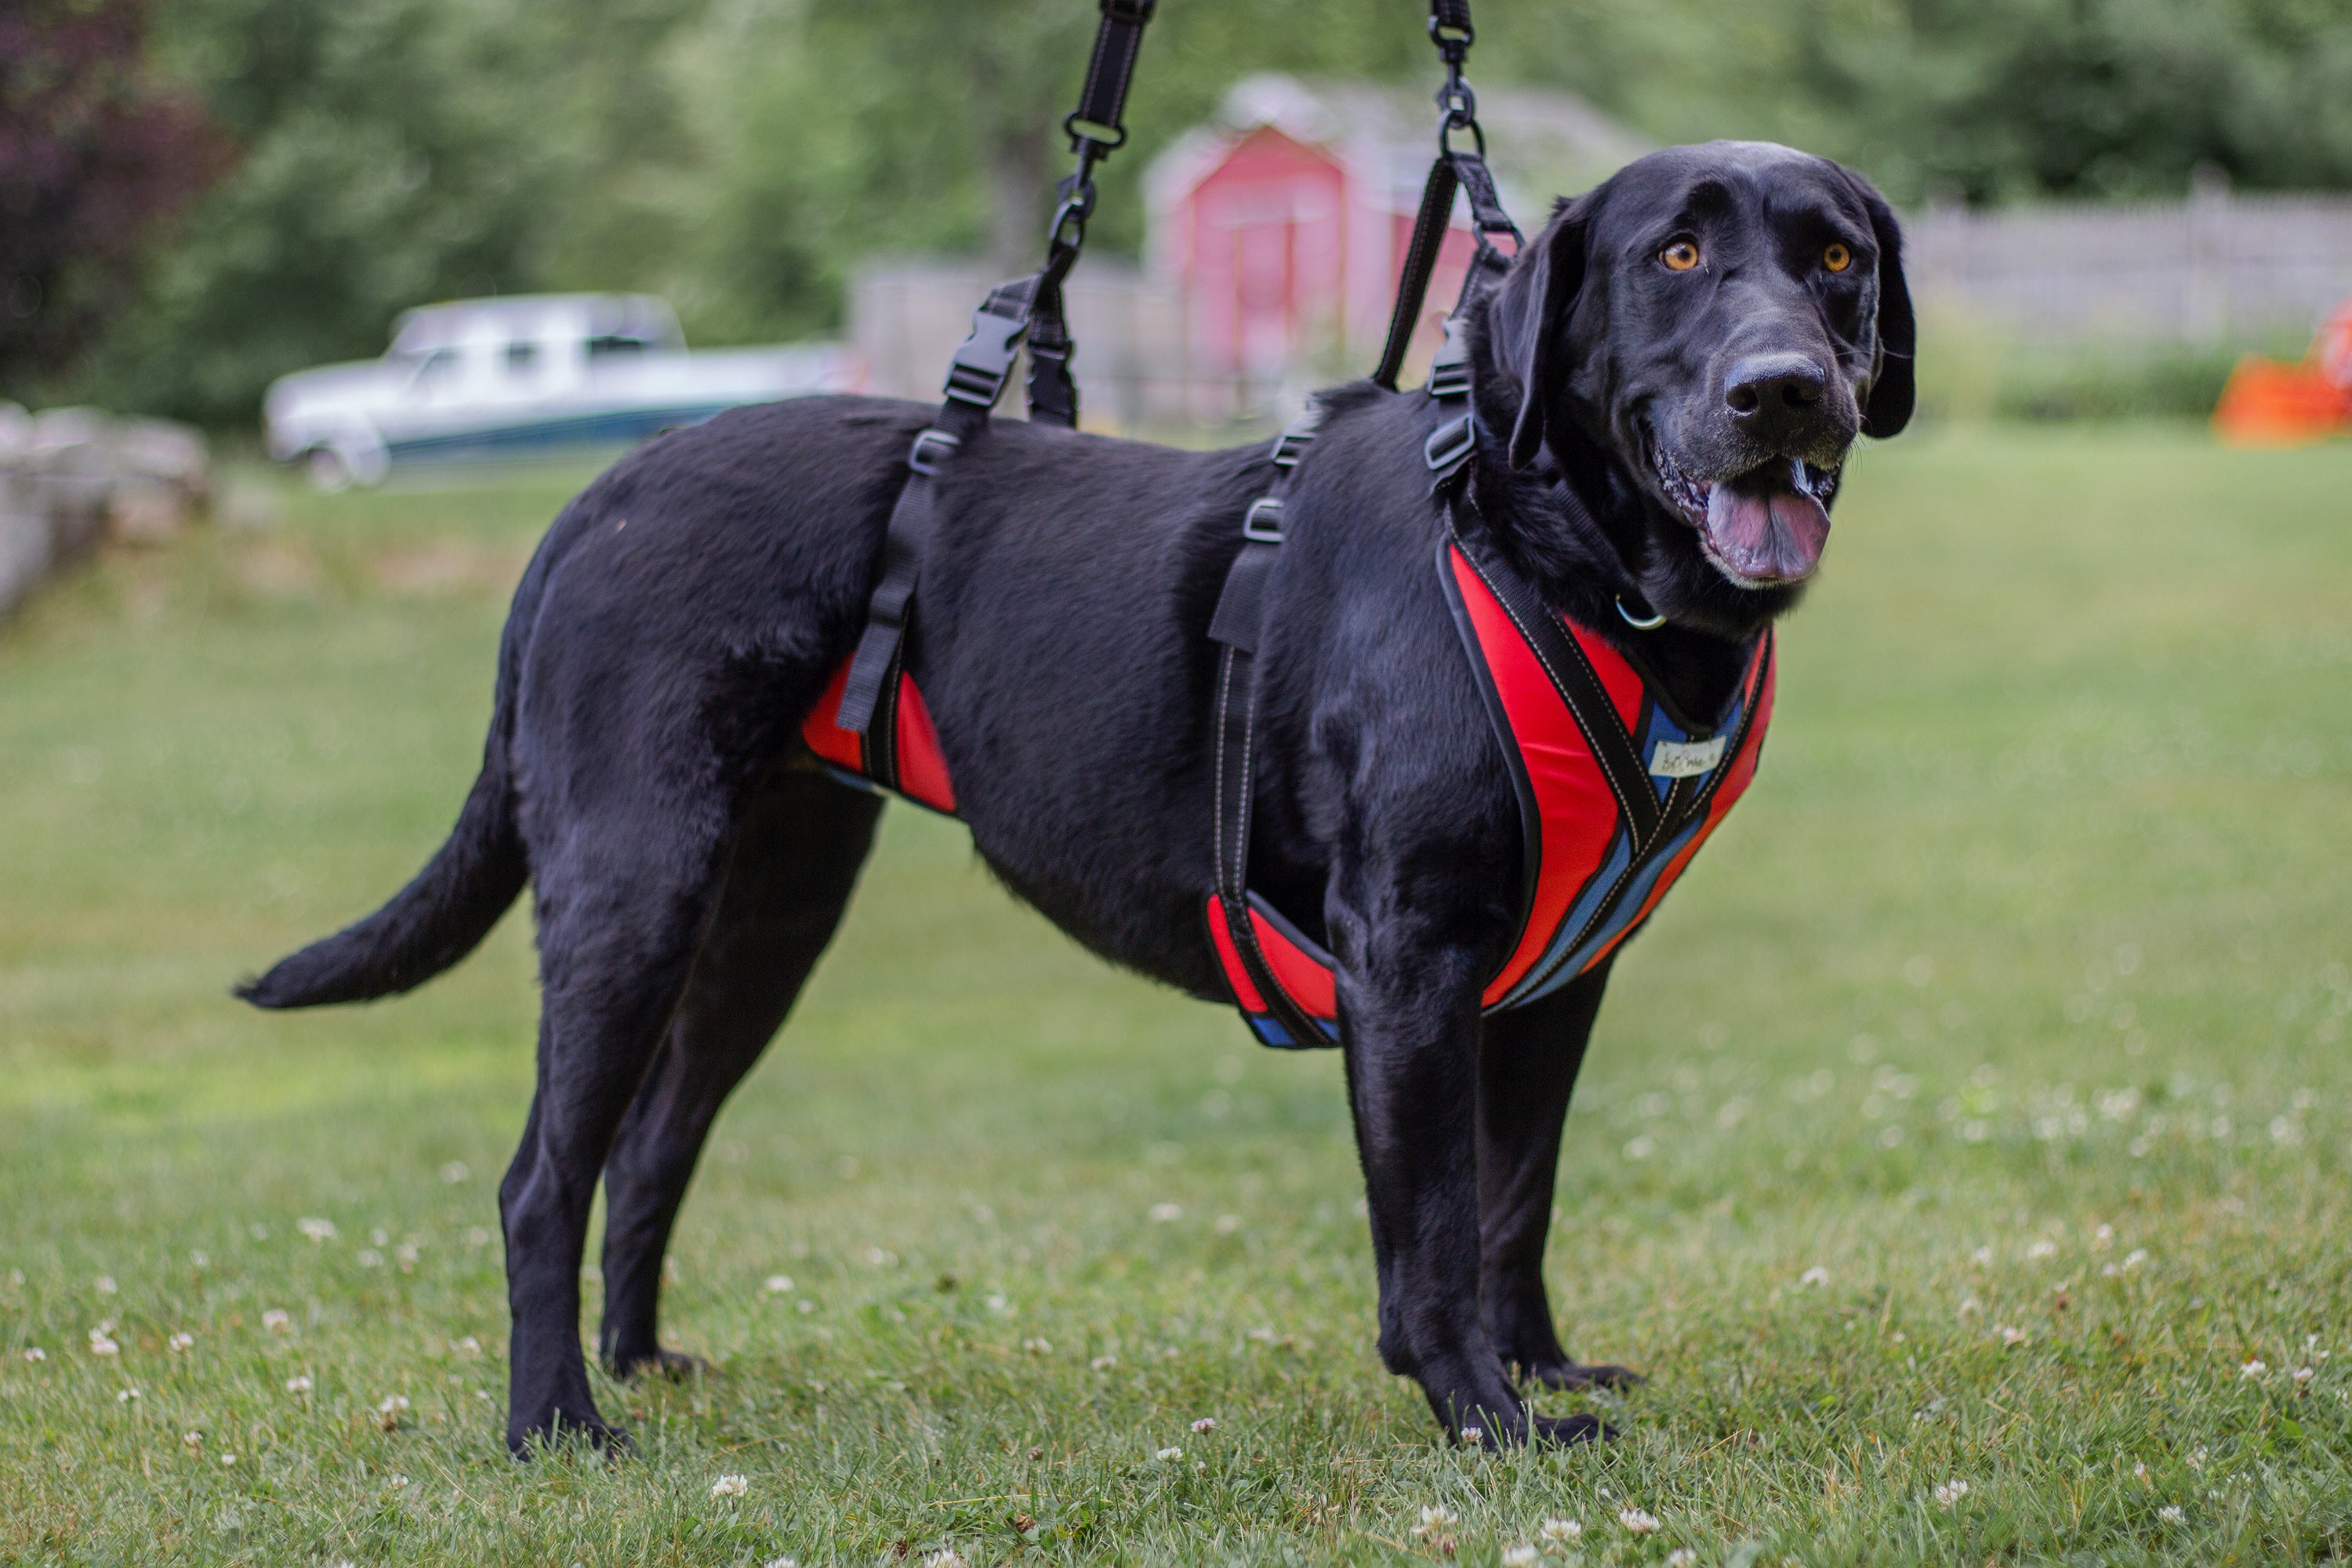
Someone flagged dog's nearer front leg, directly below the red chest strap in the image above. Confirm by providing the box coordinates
[1341,938,1599,1443]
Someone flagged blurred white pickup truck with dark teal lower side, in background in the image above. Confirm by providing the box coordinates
[261,294,861,489]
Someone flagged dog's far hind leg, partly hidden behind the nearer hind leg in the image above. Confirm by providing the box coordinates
[597,767,882,1377]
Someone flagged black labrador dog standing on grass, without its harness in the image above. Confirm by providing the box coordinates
[242,143,1912,1453]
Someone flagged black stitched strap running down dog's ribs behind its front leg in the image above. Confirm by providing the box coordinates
[1209,405,1331,1046]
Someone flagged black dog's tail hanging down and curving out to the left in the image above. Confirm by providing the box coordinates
[238,529,560,1008]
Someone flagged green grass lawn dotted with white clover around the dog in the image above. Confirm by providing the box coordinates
[0,426,2352,1568]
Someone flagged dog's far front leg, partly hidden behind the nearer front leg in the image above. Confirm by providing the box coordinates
[1477,964,1642,1389]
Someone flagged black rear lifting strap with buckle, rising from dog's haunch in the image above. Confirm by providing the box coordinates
[837,0,1157,742]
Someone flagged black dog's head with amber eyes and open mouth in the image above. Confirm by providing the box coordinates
[1479,141,1912,630]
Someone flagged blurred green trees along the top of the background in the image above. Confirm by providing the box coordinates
[13,0,2352,426]
